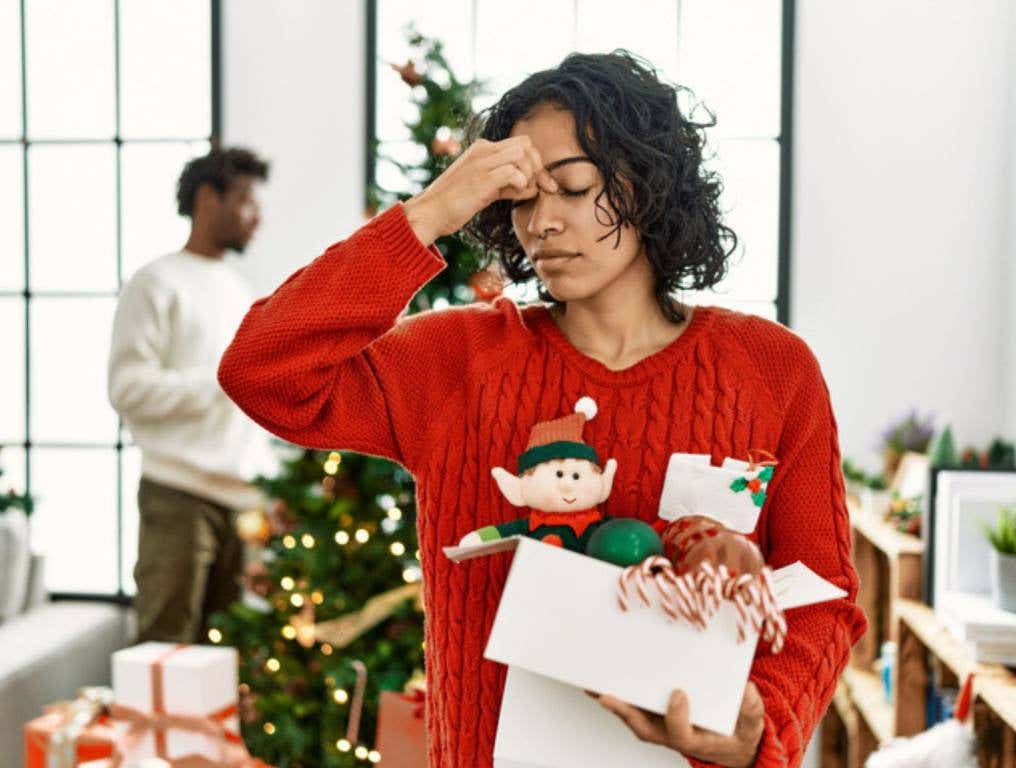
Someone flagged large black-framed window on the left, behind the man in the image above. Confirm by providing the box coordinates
[0,0,218,599]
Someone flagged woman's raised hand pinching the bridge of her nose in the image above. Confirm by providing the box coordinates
[403,135,558,246]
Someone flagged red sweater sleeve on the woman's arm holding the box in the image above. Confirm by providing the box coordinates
[691,342,868,768]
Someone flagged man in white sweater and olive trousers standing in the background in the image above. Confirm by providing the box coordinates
[108,148,274,642]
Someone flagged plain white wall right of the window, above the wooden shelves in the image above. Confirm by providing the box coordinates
[791,0,1016,467]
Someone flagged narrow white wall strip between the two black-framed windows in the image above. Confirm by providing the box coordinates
[223,0,366,295]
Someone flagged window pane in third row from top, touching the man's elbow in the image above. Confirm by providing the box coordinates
[30,298,117,444]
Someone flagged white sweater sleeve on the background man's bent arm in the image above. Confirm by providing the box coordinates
[107,273,225,423]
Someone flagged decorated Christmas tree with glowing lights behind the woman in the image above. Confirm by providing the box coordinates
[209,30,487,768]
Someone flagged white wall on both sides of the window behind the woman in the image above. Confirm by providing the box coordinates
[223,0,1016,458]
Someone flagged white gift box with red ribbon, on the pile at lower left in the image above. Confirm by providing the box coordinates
[113,643,240,760]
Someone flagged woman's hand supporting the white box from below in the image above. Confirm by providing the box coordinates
[590,682,765,768]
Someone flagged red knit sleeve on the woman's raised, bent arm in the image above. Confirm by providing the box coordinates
[218,205,464,470]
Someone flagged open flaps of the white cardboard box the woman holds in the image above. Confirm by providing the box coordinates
[445,537,846,734]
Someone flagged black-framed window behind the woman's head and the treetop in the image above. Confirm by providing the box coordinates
[367,0,793,323]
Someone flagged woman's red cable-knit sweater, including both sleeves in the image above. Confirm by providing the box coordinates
[218,205,866,768]
